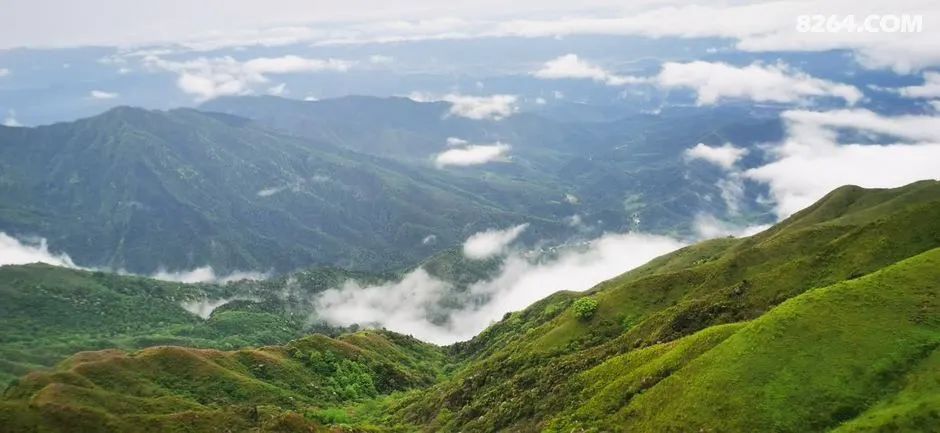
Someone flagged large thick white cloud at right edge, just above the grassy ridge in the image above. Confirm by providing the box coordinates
[744,110,940,218]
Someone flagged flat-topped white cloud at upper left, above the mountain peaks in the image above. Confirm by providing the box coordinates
[143,55,352,101]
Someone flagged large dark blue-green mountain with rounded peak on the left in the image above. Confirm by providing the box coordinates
[0,108,573,274]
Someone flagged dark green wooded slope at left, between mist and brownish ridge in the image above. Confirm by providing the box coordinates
[0,264,382,387]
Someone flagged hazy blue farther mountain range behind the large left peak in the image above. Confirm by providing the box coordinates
[200,96,782,236]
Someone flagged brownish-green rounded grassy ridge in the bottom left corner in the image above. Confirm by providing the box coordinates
[0,331,445,431]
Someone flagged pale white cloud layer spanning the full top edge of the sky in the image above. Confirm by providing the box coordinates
[7,0,940,72]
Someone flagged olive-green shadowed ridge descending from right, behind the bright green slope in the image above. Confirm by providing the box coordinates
[398,182,940,431]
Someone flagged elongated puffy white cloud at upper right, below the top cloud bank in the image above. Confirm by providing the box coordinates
[655,61,863,105]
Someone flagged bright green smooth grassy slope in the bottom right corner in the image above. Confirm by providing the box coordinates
[555,249,940,432]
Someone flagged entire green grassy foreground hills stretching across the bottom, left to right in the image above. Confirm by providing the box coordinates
[0,181,940,432]
